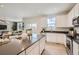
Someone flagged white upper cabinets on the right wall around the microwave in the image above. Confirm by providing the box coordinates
[67,4,79,27]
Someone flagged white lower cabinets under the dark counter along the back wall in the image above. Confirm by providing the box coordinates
[46,33,66,45]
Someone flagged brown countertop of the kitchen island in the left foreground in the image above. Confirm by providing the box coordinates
[0,35,45,55]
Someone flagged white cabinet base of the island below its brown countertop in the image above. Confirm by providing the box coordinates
[26,37,45,55]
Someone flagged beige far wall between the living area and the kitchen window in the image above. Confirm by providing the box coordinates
[23,16,47,34]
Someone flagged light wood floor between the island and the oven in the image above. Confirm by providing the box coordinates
[43,42,67,55]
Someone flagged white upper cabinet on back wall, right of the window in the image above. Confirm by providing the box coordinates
[56,15,67,27]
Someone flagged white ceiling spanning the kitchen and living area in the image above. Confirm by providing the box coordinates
[0,3,75,18]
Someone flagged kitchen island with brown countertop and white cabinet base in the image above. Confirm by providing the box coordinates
[0,34,45,55]
